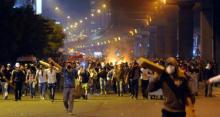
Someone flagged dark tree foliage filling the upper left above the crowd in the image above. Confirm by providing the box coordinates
[0,0,65,62]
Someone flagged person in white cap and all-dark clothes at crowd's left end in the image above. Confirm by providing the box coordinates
[11,63,25,101]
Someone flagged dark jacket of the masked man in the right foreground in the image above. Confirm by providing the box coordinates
[148,72,195,112]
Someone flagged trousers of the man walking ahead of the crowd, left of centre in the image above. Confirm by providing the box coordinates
[63,88,74,112]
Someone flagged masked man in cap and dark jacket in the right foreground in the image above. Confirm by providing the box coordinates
[148,57,195,117]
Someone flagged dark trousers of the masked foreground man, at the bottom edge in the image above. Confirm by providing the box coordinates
[162,109,186,117]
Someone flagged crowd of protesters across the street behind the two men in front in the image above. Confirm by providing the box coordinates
[0,56,217,101]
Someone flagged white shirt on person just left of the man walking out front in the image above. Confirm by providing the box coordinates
[45,68,58,84]
